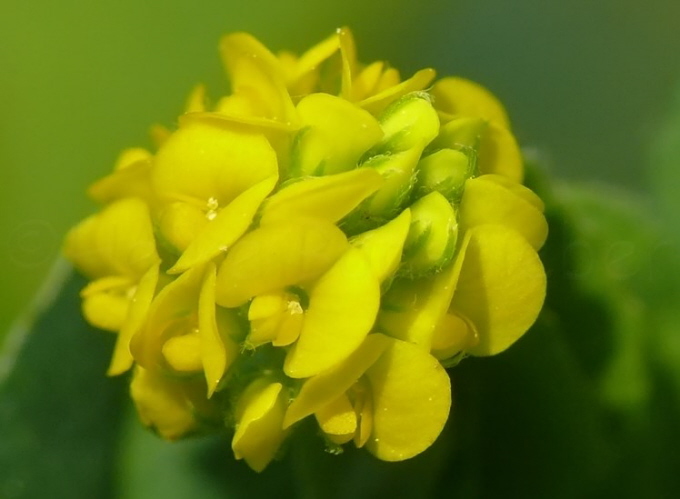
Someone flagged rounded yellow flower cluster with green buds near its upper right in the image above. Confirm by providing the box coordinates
[65,29,547,471]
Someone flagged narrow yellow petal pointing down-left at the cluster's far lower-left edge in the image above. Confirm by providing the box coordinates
[107,264,159,376]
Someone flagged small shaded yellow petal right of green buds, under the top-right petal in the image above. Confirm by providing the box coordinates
[478,122,524,184]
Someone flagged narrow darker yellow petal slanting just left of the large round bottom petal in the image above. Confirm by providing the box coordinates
[283,334,389,428]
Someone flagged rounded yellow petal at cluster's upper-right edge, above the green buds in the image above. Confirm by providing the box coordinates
[430,77,510,128]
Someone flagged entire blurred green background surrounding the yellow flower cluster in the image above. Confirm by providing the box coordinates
[0,0,680,499]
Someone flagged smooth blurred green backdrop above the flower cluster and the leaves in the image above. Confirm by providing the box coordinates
[0,0,680,344]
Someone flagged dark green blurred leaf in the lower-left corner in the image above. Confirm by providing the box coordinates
[0,262,125,499]
